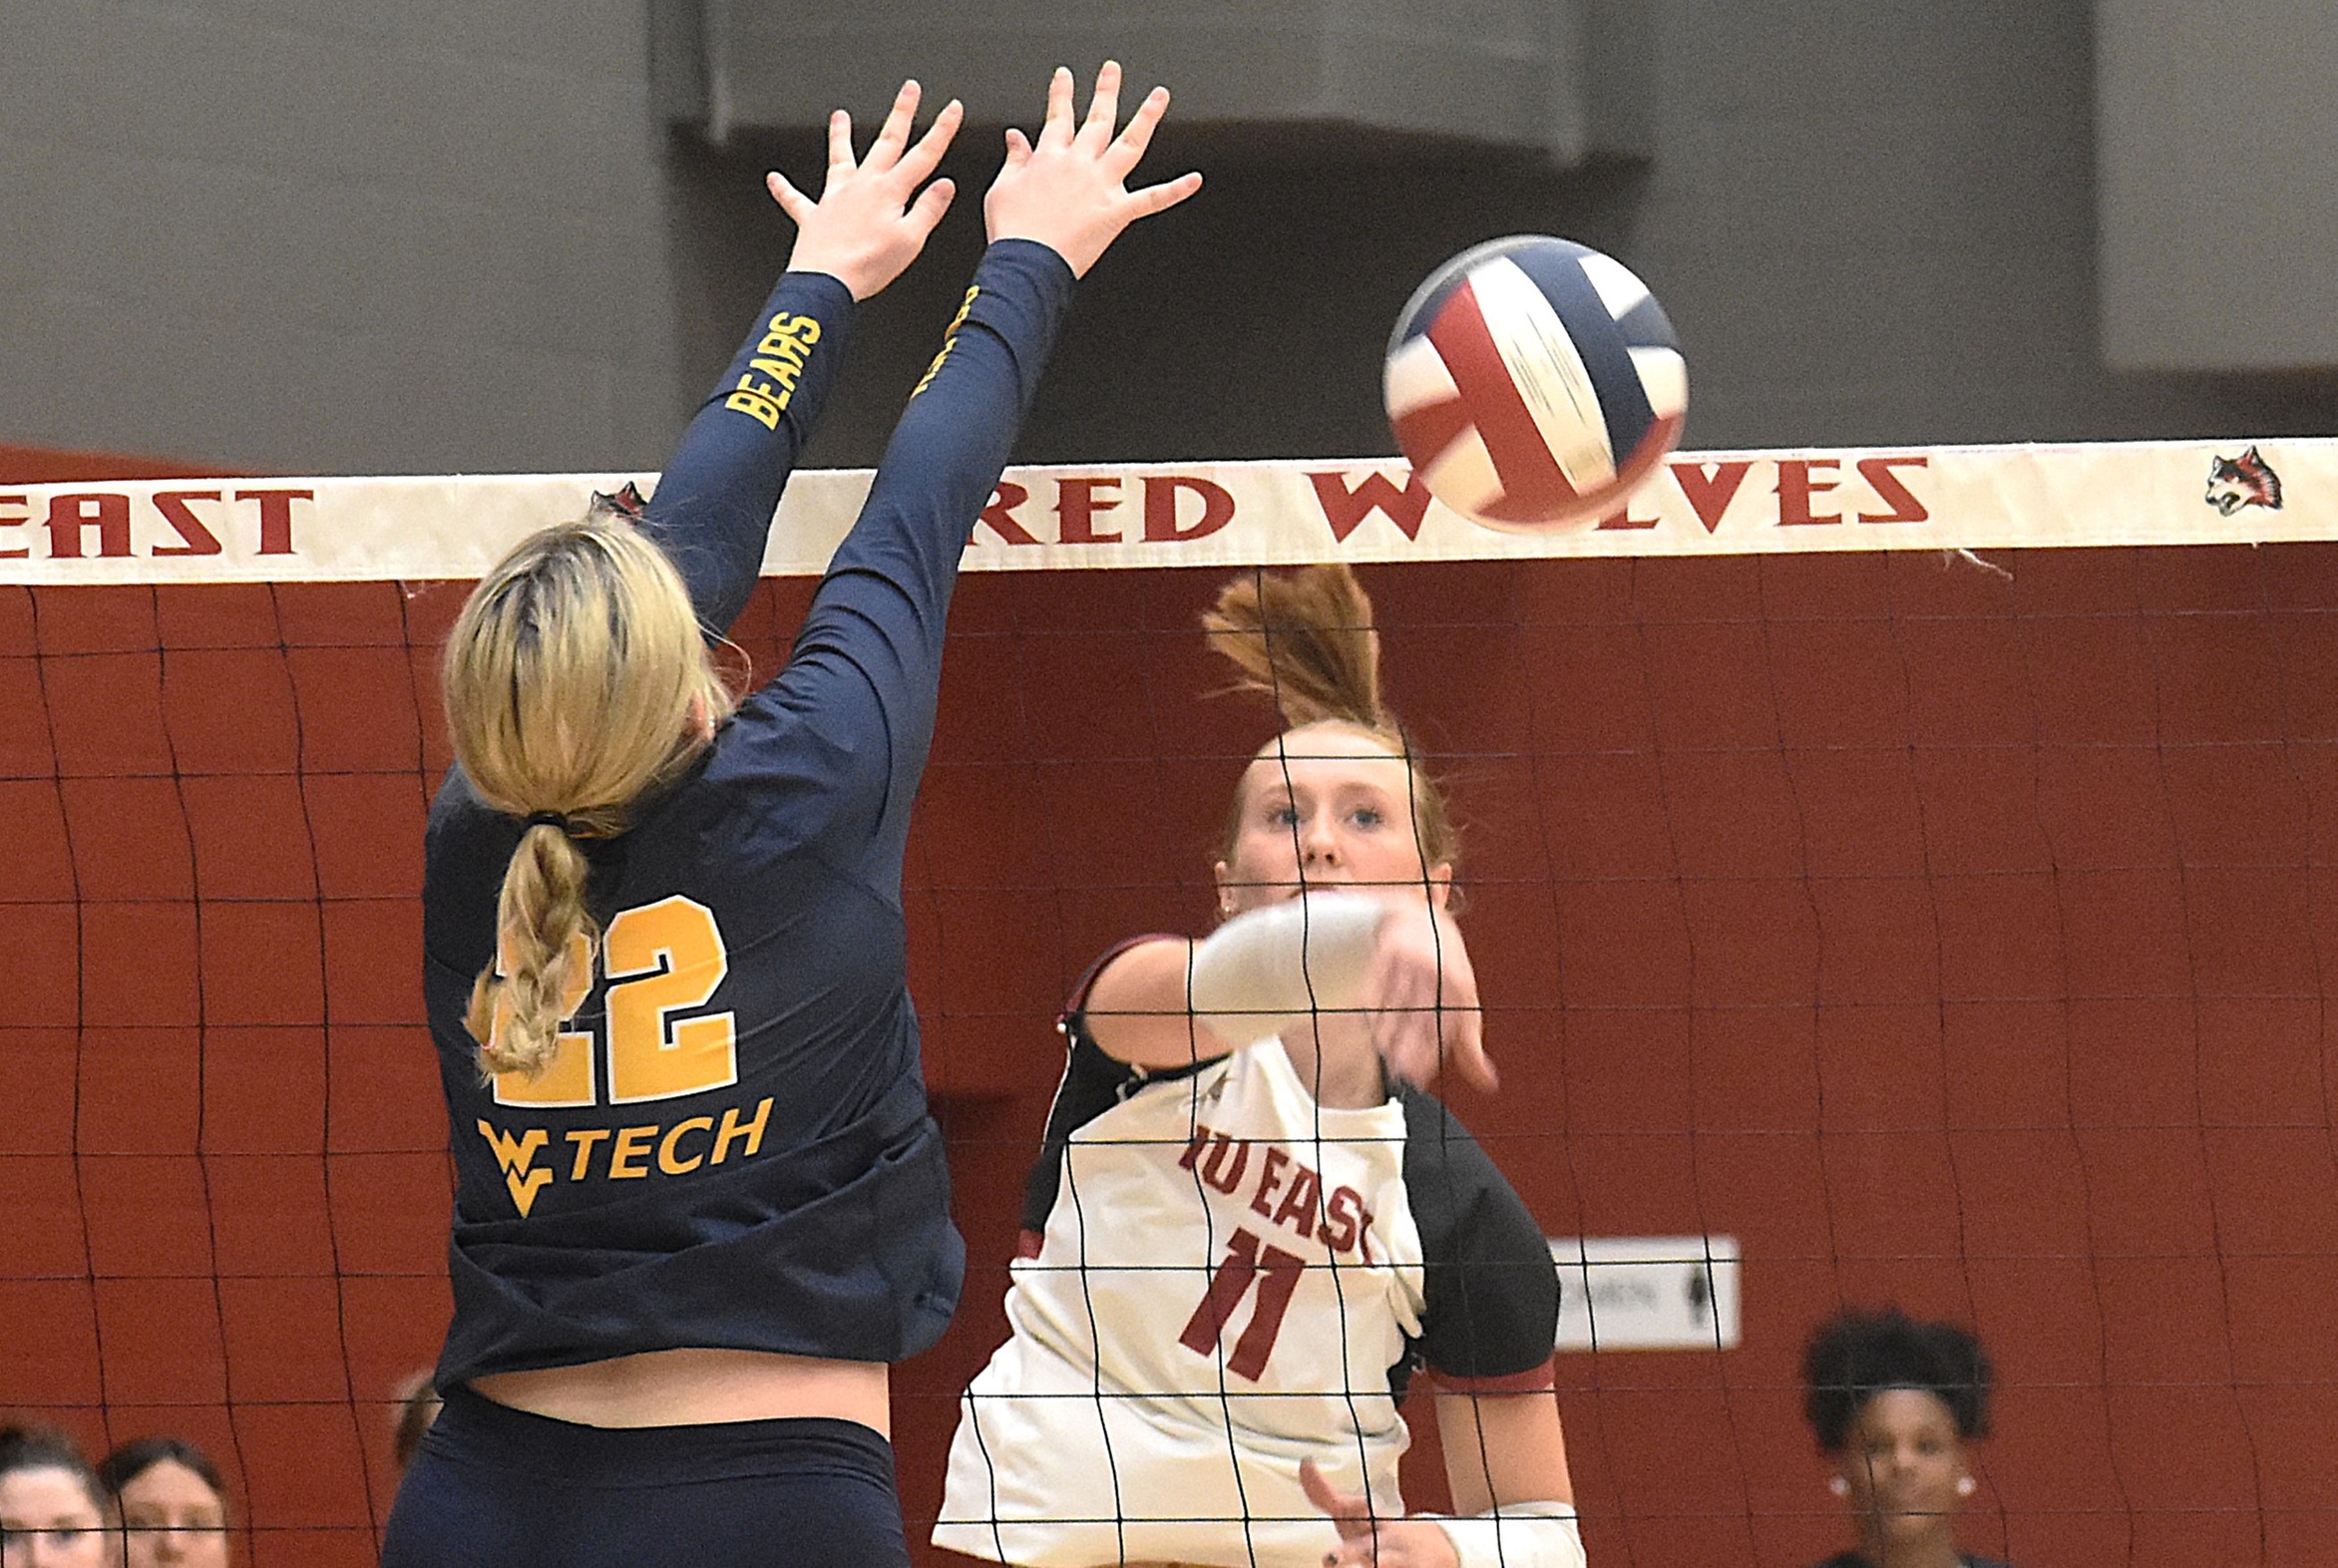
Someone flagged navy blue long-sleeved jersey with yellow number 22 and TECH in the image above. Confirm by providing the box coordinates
[423,240,1071,1385]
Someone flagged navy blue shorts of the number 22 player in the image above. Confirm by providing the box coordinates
[381,1388,910,1568]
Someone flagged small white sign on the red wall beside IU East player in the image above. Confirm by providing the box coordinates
[1550,1236,1738,1351]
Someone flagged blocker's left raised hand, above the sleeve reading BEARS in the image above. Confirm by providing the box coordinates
[764,82,964,299]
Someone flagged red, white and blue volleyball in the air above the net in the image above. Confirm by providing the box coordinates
[1384,233,1688,531]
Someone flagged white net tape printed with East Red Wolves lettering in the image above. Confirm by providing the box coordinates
[0,437,2338,585]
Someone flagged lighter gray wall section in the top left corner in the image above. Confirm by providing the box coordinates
[0,0,675,472]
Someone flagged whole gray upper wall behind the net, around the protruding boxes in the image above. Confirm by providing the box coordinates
[0,0,2338,472]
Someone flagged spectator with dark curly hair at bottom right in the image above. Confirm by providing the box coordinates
[1802,1309,2006,1568]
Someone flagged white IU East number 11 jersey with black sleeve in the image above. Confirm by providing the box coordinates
[933,995,1557,1568]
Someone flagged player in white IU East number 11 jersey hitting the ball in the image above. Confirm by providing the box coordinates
[933,568,1581,1568]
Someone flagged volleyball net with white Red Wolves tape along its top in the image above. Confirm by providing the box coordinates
[0,442,2338,1563]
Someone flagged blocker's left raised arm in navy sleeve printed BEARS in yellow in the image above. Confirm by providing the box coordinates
[647,273,856,633]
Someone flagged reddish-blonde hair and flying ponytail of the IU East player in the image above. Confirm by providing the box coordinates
[1202,566,1461,870]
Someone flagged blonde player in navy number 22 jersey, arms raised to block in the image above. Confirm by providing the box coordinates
[381,66,1199,1568]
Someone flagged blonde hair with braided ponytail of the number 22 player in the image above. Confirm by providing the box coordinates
[444,507,732,1075]
